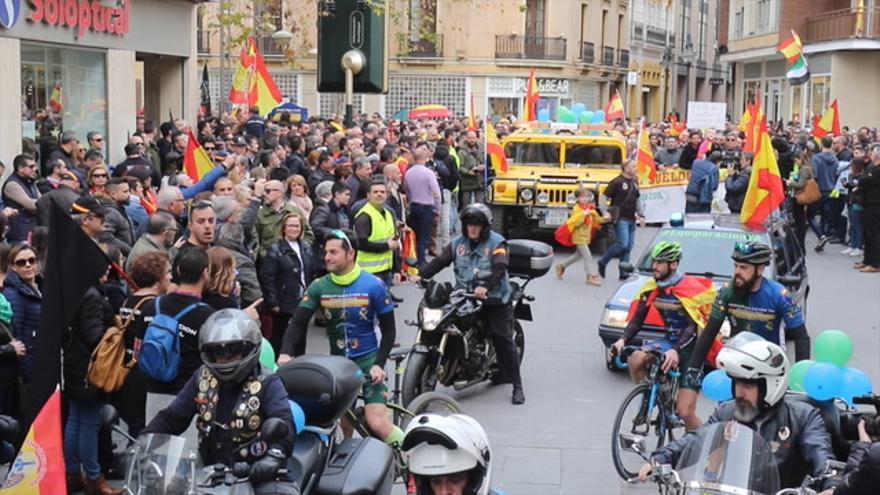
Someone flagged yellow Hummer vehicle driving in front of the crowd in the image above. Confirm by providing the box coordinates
[488,123,626,237]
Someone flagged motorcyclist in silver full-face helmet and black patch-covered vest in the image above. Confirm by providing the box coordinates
[141,309,295,493]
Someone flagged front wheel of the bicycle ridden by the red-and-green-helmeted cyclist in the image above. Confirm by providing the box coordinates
[611,383,665,481]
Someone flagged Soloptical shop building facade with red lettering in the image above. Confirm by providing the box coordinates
[0,0,198,167]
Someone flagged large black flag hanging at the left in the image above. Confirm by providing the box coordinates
[22,200,110,431]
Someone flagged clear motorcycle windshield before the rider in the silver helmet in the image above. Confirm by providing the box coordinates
[126,433,201,495]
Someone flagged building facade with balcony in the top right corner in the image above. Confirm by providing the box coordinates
[722,0,880,126]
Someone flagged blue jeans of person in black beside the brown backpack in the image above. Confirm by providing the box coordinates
[64,399,102,480]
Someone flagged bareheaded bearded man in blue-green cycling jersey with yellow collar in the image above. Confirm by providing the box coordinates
[278,230,403,446]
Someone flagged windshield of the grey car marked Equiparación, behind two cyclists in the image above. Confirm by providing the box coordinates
[638,227,772,278]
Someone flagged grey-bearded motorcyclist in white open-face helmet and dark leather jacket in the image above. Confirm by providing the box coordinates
[639,332,834,488]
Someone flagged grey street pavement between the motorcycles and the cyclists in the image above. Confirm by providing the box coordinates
[358,227,880,495]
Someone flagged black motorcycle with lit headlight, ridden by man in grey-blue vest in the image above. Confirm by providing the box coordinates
[402,239,553,404]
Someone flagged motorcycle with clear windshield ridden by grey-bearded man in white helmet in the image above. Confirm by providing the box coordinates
[619,421,846,495]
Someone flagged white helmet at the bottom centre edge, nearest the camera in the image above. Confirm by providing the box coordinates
[403,413,492,495]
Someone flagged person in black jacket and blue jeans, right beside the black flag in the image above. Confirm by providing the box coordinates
[63,268,122,495]
